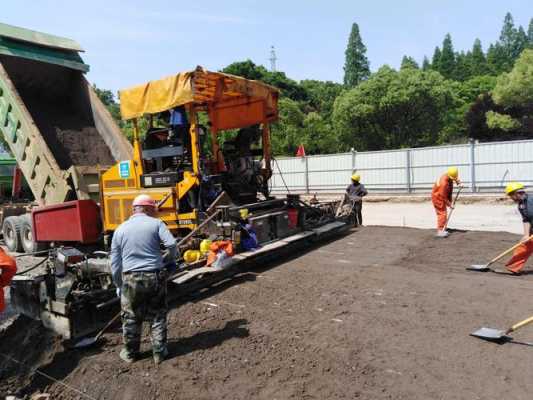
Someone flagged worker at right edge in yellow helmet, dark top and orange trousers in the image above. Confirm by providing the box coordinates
[505,182,533,275]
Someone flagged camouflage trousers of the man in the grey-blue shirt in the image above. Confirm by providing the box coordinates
[120,272,167,355]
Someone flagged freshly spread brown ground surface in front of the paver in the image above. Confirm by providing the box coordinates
[0,227,533,400]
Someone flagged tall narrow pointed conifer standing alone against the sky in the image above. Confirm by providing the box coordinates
[344,23,370,87]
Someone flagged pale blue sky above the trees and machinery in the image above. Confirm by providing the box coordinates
[0,0,533,91]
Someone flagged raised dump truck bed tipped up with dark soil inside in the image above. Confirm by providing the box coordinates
[0,24,132,204]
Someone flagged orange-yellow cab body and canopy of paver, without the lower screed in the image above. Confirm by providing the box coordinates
[101,67,279,233]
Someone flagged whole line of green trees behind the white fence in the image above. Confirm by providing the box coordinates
[98,13,533,155]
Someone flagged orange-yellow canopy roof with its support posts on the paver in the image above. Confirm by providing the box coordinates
[119,66,279,179]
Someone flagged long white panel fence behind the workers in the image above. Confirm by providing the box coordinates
[271,140,533,193]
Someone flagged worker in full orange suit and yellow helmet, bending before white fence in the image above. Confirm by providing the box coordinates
[431,167,461,237]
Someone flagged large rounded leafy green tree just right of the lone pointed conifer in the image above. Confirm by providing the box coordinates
[333,66,457,150]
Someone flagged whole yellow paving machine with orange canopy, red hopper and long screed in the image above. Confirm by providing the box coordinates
[10,62,349,339]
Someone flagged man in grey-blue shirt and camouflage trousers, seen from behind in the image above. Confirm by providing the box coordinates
[111,194,177,364]
